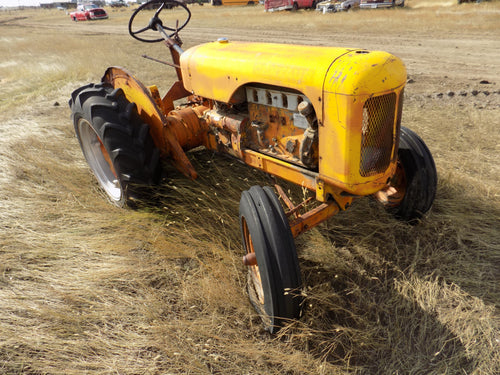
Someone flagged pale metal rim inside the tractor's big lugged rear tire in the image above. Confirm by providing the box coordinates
[78,118,123,202]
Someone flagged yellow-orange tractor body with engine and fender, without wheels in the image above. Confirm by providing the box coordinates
[103,40,406,239]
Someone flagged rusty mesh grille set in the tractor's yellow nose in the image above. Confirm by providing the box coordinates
[359,93,396,177]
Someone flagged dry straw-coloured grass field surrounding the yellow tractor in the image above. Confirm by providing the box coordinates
[0,0,500,375]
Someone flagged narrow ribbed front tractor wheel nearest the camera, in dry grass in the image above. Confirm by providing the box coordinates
[239,186,302,333]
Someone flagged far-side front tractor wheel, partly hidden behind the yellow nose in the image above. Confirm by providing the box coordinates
[374,126,437,222]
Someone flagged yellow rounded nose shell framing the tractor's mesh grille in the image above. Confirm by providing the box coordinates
[319,51,406,195]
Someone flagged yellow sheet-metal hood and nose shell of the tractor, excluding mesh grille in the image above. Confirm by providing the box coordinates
[180,41,406,197]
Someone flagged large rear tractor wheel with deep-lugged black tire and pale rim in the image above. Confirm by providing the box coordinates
[69,84,161,207]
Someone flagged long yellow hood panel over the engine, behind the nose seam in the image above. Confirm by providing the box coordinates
[180,39,351,103]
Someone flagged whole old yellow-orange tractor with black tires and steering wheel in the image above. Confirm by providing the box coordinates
[69,0,437,332]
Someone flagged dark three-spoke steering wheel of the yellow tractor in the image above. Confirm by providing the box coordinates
[128,0,191,43]
